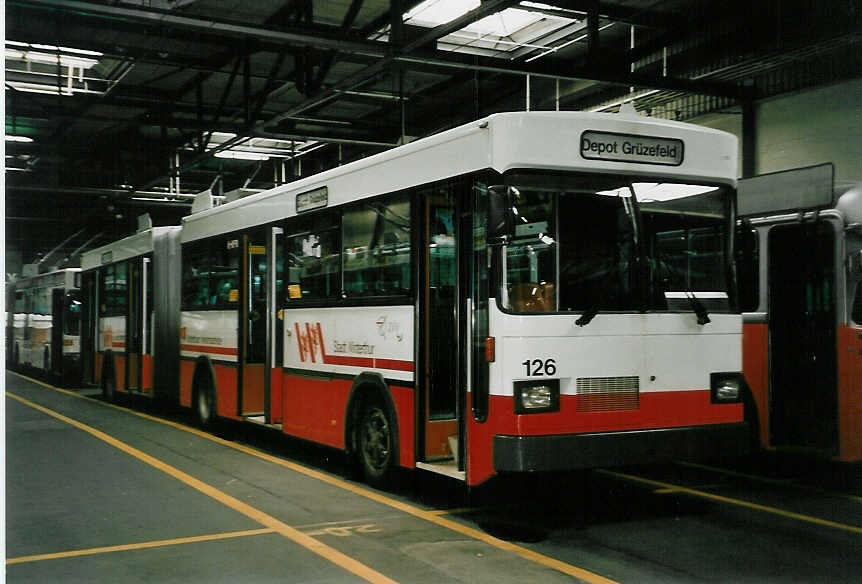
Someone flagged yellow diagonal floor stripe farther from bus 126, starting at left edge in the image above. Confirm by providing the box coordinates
[6,391,395,584]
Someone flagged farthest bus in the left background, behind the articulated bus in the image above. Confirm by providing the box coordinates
[6,268,82,385]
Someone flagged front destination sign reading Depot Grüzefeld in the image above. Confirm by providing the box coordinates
[581,130,684,166]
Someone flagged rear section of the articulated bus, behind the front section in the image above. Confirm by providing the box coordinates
[81,221,180,403]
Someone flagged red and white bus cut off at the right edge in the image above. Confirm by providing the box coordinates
[737,164,862,462]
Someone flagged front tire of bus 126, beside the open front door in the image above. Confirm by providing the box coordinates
[356,400,395,487]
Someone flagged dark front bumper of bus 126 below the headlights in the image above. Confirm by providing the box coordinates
[494,422,750,472]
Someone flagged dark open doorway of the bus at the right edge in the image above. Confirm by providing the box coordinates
[768,220,838,453]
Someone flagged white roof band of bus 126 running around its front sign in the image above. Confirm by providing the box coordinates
[181,112,738,242]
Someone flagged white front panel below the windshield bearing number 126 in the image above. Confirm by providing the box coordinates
[490,299,742,397]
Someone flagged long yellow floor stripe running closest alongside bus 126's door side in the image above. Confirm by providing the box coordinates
[5,378,617,584]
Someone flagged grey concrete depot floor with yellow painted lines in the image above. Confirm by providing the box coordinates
[6,374,862,584]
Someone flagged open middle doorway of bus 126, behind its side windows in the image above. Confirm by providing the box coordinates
[238,229,270,422]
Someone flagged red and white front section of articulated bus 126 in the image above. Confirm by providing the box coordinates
[180,112,747,485]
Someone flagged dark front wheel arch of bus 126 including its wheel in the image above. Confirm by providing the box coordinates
[344,373,400,487]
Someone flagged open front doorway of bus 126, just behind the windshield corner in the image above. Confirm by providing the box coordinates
[417,185,464,474]
